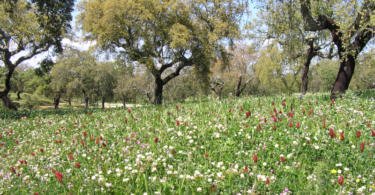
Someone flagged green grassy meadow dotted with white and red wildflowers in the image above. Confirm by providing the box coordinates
[0,94,375,194]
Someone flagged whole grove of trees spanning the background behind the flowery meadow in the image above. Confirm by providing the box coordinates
[0,0,375,109]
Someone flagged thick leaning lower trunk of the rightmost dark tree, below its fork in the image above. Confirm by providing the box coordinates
[331,54,355,99]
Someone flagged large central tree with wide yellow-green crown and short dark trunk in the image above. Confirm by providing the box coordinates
[81,0,246,104]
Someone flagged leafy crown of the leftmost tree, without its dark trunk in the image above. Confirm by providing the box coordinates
[0,0,74,52]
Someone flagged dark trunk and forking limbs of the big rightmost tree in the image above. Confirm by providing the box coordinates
[300,0,375,99]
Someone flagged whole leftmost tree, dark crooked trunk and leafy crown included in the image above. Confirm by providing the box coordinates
[0,0,74,109]
